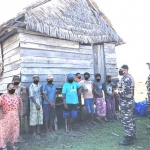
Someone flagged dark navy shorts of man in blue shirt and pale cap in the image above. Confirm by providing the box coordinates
[43,104,56,121]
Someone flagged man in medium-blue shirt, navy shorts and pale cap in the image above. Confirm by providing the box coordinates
[43,75,56,133]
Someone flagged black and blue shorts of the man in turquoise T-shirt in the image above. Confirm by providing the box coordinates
[63,104,78,118]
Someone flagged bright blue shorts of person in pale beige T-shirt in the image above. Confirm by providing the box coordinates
[84,98,94,114]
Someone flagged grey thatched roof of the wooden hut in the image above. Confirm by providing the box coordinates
[0,0,123,45]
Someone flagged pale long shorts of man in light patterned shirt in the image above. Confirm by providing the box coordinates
[30,105,43,126]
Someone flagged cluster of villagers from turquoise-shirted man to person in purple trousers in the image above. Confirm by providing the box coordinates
[62,72,115,132]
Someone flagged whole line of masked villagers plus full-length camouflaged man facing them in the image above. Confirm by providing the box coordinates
[0,65,136,150]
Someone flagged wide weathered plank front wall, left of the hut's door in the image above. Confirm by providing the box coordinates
[20,33,94,87]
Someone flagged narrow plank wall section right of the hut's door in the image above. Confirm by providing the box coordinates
[104,43,118,79]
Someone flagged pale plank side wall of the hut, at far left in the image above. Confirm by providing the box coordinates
[0,34,20,93]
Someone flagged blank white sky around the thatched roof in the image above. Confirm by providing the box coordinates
[0,0,150,81]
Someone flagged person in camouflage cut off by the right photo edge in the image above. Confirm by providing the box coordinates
[146,75,150,123]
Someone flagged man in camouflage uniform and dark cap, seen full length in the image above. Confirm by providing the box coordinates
[119,65,136,146]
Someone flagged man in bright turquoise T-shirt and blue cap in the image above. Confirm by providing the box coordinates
[62,73,82,132]
